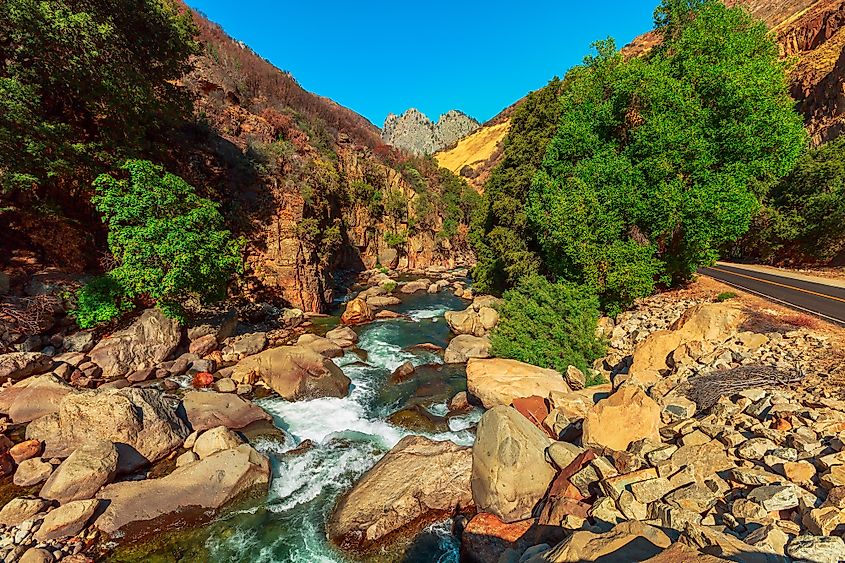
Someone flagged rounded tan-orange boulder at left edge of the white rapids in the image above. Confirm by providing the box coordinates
[232,346,351,401]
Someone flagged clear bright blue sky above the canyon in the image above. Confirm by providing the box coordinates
[188,0,658,126]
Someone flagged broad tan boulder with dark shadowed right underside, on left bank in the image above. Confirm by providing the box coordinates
[26,387,188,473]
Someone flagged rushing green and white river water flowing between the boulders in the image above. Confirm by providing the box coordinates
[113,292,480,563]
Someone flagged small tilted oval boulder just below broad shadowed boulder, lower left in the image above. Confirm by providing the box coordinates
[38,440,117,504]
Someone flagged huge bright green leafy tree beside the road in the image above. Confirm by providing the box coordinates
[526,0,806,313]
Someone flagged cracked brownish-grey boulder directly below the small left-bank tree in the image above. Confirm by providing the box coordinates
[88,309,182,377]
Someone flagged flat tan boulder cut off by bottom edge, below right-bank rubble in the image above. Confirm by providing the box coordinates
[527,520,672,563]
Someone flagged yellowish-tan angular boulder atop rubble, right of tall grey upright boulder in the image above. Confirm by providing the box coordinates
[582,385,661,451]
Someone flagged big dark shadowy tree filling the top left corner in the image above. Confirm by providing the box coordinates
[0,0,197,203]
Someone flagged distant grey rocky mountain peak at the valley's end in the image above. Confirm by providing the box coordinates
[382,108,481,155]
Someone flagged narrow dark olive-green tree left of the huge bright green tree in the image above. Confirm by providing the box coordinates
[470,78,563,293]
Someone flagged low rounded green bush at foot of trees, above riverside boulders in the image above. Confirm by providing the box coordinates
[491,275,605,373]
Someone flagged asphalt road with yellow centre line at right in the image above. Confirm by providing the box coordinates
[699,264,845,326]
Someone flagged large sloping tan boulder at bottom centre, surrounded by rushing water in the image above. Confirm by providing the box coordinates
[328,436,472,550]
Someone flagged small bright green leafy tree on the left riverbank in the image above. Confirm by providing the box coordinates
[76,160,244,326]
